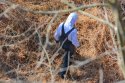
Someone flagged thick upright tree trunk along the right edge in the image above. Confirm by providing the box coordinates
[109,0,125,78]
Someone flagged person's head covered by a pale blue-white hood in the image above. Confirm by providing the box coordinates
[65,12,78,27]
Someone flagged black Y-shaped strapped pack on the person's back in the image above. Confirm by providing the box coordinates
[59,23,75,49]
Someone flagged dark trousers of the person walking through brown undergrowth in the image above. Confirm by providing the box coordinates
[60,45,75,78]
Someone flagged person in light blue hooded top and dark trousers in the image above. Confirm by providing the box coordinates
[54,12,80,78]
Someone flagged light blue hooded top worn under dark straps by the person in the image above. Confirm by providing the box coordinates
[54,13,79,47]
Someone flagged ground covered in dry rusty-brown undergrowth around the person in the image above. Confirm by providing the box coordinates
[0,0,123,83]
